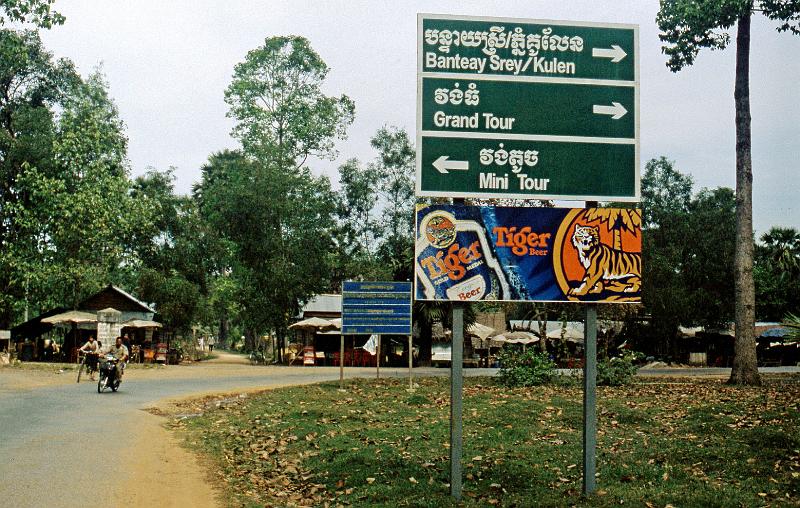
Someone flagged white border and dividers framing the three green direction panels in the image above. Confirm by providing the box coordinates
[415,13,641,203]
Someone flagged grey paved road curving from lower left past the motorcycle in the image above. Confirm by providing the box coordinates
[0,353,494,507]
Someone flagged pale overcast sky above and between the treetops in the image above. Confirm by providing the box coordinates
[43,0,800,233]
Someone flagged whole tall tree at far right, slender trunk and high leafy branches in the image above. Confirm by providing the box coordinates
[656,0,800,385]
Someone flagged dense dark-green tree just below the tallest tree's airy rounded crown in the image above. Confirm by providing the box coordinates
[200,150,334,354]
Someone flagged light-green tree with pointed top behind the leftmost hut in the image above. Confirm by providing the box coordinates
[21,72,150,307]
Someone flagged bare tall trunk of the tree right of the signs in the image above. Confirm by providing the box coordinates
[728,12,761,385]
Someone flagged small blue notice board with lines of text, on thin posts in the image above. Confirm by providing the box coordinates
[342,281,411,335]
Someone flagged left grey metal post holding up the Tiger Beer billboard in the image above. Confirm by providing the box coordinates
[450,303,464,500]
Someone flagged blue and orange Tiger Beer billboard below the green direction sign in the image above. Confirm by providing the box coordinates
[415,205,642,303]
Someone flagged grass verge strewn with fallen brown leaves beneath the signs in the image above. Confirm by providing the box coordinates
[170,376,800,507]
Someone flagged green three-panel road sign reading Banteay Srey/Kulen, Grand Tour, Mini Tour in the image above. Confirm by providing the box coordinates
[416,14,640,201]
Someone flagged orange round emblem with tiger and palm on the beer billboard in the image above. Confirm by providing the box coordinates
[553,208,642,302]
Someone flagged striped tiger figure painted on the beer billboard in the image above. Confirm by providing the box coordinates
[569,224,642,296]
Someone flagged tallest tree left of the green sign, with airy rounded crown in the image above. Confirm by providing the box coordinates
[219,37,354,352]
